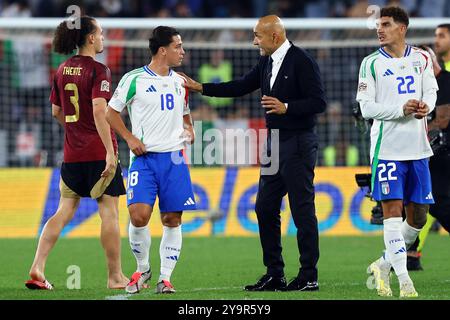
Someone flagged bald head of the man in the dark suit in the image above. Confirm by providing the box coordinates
[253,15,286,56]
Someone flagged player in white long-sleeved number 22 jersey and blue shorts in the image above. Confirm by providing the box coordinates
[356,7,438,297]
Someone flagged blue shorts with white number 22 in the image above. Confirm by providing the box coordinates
[372,159,434,204]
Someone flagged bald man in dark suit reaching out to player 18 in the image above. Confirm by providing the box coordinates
[181,15,326,291]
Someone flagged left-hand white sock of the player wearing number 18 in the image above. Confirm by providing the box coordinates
[128,221,151,272]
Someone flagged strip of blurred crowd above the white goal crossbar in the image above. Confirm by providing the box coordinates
[0,0,450,18]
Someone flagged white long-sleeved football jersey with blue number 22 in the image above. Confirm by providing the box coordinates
[356,45,438,161]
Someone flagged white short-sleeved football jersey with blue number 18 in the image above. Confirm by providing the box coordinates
[109,66,190,157]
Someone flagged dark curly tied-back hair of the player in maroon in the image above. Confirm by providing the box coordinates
[53,16,97,54]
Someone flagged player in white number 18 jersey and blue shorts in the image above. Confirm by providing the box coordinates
[107,26,195,293]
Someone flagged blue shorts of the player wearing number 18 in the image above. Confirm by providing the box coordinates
[127,151,196,213]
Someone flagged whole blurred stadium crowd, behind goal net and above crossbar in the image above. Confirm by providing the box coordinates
[0,0,442,167]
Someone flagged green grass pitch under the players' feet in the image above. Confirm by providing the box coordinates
[0,234,450,300]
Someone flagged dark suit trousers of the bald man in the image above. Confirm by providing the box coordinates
[255,131,319,280]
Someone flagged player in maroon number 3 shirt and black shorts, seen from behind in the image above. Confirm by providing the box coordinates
[26,16,128,290]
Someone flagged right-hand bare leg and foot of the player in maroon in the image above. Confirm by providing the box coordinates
[98,195,129,289]
